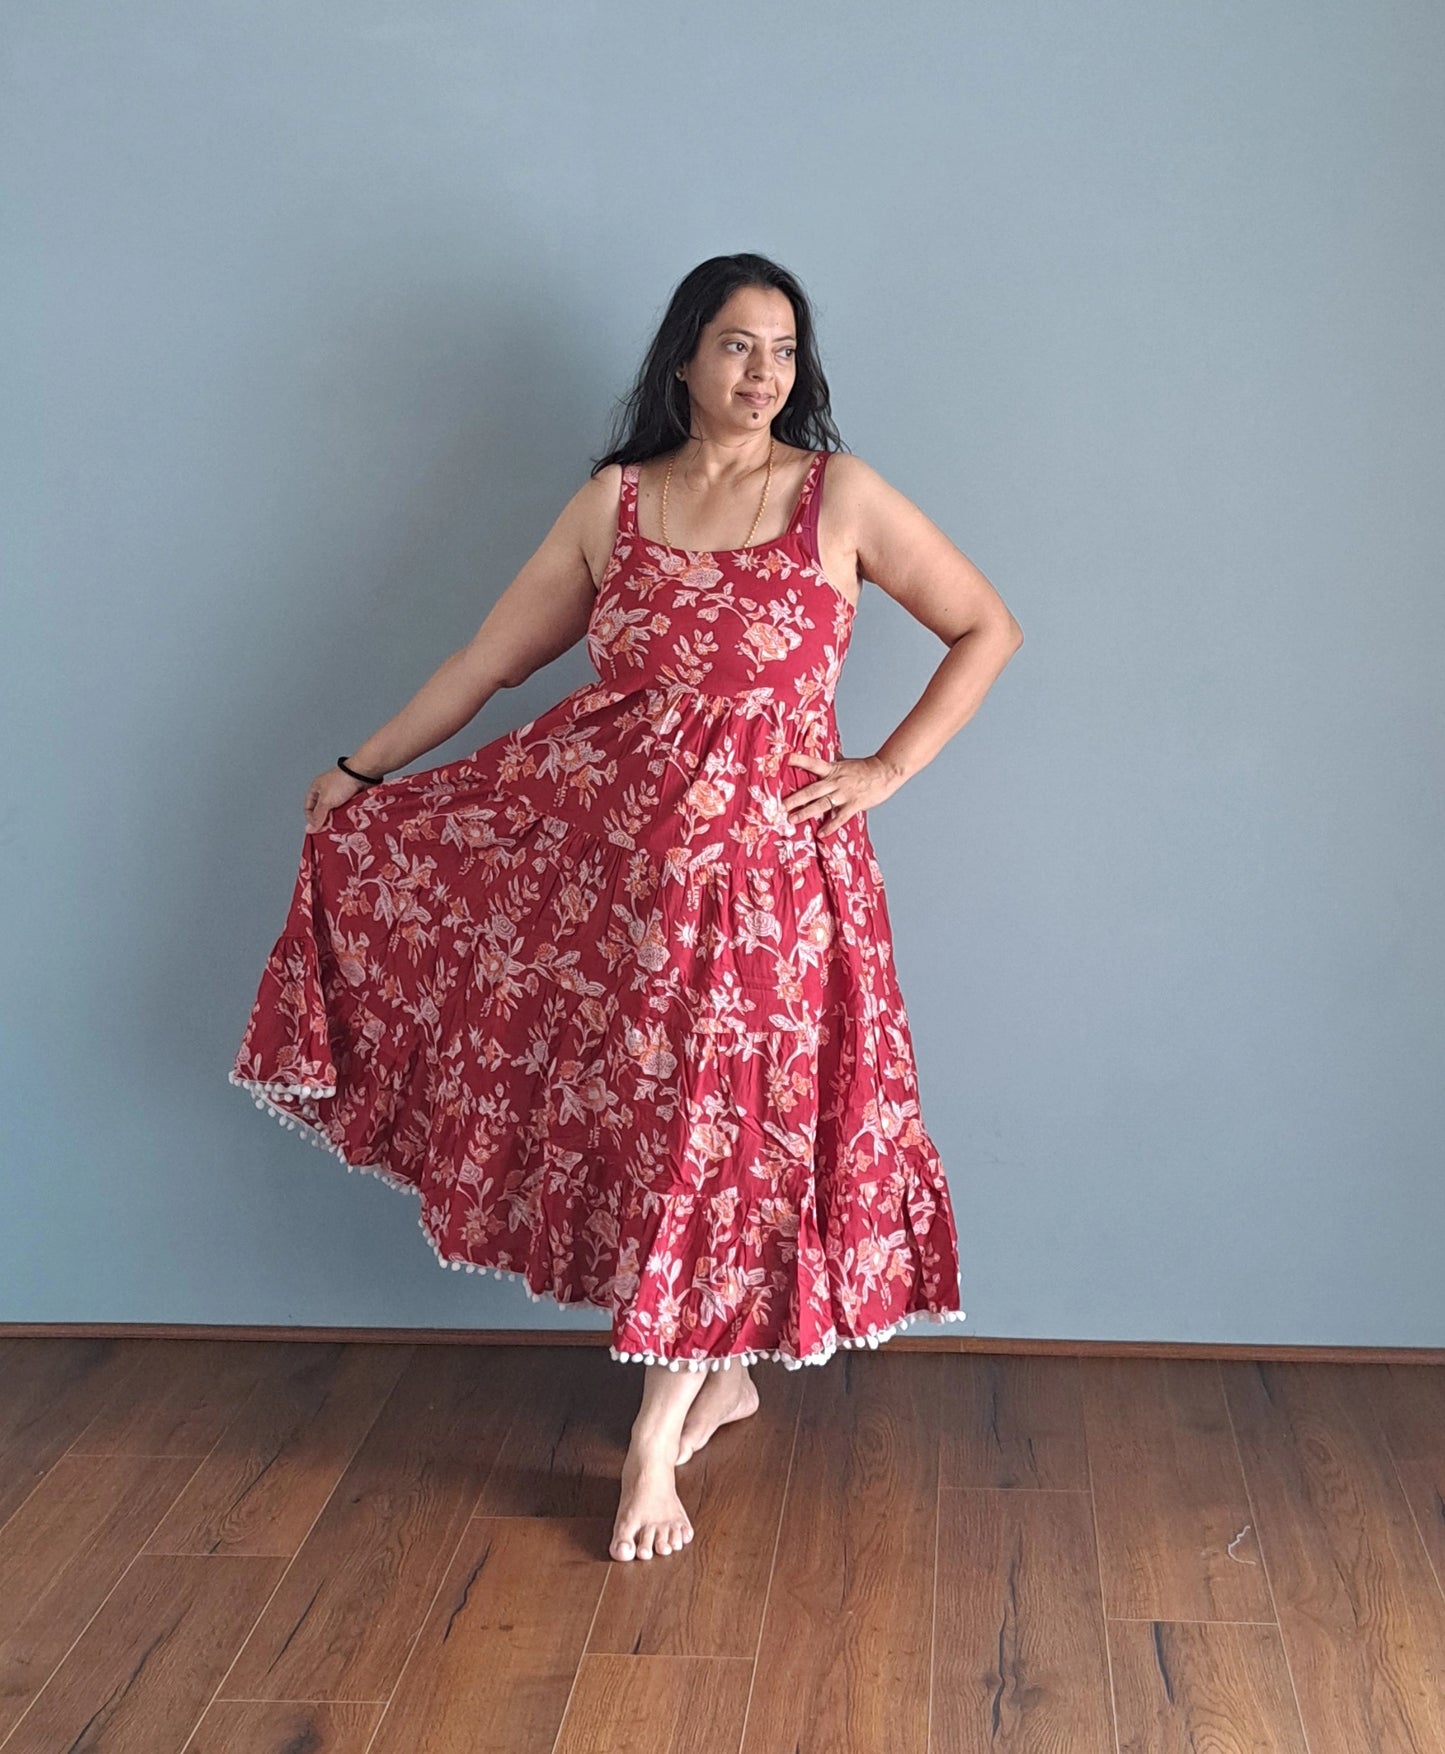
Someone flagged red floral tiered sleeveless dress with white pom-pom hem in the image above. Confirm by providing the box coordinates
[230,451,963,1368]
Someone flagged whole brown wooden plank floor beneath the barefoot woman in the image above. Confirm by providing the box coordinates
[0,1337,1445,1754]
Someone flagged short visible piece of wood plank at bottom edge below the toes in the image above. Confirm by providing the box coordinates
[556,1648,757,1754]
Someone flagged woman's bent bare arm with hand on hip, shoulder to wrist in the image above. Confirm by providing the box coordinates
[828,454,1024,789]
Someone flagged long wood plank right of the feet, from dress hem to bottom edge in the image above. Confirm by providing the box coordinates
[740,1347,952,1754]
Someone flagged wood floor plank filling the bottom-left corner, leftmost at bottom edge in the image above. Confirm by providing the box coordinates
[5,1554,286,1754]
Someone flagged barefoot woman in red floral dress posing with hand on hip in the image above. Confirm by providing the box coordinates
[230,254,1022,1559]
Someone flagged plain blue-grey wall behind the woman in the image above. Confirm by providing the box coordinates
[0,0,1445,1345]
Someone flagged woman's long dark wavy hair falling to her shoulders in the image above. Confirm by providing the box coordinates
[591,251,844,475]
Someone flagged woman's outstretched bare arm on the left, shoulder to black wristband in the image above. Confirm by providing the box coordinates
[349,465,617,774]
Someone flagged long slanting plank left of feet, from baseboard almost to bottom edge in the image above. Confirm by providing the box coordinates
[219,1345,535,1700]
